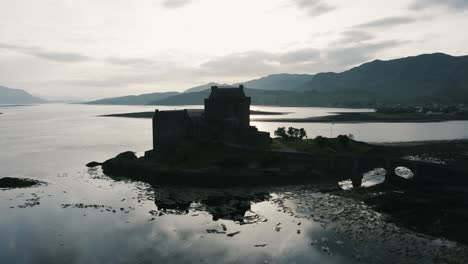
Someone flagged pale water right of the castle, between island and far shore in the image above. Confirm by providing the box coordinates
[252,106,468,142]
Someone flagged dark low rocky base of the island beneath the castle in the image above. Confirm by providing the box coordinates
[87,151,337,188]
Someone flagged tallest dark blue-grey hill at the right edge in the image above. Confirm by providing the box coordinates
[298,53,468,101]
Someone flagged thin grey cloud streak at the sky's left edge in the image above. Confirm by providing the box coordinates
[0,43,91,63]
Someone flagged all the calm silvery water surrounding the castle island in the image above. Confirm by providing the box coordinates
[0,104,468,263]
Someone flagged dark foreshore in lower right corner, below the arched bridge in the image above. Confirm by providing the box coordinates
[331,179,468,245]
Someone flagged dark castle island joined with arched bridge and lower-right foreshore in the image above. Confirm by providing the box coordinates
[87,86,468,242]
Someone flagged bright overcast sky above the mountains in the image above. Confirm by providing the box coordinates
[0,0,468,99]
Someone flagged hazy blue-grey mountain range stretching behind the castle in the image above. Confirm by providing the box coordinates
[81,53,468,107]
